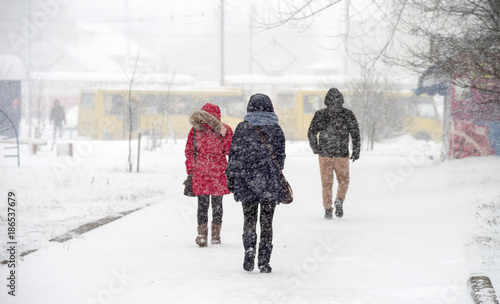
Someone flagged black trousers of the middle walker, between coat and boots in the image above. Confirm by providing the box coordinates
[242,202,276,250]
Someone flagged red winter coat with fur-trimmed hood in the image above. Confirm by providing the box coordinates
[184,103,233,196]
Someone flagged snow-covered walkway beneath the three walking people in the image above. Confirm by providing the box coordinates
[0,138,492,304]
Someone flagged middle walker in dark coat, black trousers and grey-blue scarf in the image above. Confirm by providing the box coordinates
[226,94,286,273]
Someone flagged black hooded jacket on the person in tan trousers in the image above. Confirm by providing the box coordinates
[307,88,360,159]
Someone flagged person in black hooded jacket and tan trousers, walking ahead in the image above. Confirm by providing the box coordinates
[307,88,360,219]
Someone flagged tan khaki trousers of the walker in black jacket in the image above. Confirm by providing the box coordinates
[319,156,349,210]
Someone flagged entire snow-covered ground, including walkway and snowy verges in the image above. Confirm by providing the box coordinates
[0,132,500,304]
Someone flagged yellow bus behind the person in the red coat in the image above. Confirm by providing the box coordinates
[78,87,246,140]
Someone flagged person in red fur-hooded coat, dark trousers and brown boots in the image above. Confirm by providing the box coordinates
[185,103,233,247]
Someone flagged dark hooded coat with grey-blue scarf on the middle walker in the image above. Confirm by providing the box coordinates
[226,94,286,203]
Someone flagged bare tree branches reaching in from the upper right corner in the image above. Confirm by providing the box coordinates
[258,0,500,92]
